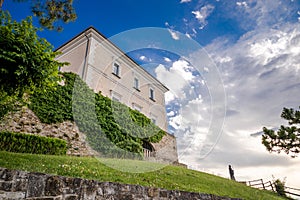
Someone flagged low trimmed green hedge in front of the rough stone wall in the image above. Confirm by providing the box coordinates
[0,131,67,155]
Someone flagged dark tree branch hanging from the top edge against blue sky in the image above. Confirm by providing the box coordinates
[0,0,77,31]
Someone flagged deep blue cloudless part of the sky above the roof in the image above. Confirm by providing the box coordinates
[3,0,270,48]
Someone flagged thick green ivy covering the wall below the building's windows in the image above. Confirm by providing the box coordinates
[29,73,166,158]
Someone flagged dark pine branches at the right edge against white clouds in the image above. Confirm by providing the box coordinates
[262,106,300,157]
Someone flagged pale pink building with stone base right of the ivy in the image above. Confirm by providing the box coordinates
[57,27,178,161]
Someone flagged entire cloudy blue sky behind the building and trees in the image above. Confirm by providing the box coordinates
[3,0,300,191]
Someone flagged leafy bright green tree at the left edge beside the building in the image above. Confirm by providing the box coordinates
[0,12,66,97]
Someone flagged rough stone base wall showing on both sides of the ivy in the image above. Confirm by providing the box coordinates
[0,107,178,163]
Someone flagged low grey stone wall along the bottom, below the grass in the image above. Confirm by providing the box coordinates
[0,168,239,200]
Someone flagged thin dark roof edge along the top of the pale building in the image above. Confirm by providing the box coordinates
[54,26,169,91]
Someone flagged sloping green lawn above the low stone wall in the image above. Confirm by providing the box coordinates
[0,151,281,200]
